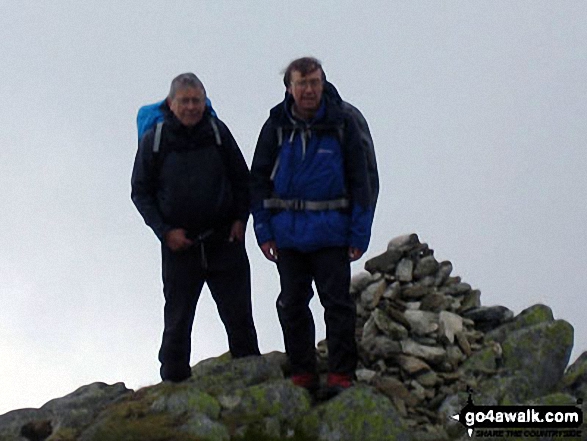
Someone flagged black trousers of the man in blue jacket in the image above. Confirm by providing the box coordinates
[277,248,357,376]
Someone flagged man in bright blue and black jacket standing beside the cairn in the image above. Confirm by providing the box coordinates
[251,58,375,394]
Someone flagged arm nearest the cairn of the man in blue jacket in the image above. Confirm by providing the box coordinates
[343,116,375,260]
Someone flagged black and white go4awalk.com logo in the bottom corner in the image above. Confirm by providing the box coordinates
[451,389,583,439]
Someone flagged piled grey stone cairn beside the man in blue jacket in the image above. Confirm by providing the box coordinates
[318,234,513,433]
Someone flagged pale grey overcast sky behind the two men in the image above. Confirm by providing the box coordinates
[0,0,587,414]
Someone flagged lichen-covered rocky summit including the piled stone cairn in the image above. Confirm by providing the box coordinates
[0,234,587,441]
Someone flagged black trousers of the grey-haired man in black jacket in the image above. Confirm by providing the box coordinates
[159,240,260,372]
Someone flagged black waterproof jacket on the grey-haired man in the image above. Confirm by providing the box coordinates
[131,104,250,241]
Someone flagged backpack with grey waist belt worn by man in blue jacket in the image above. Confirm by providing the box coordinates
[272,101,379,210]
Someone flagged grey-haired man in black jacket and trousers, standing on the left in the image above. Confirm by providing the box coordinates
[131,73,259,382]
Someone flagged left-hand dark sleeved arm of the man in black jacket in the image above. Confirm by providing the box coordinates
[131,130,172,242]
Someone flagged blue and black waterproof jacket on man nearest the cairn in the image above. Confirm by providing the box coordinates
[251,82,375,252]
